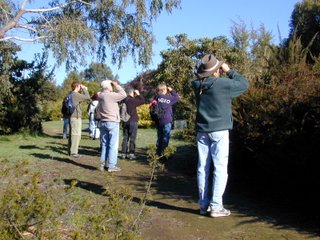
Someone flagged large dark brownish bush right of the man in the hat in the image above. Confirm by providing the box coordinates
[233,59,320,188]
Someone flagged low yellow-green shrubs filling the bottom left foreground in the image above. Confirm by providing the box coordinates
[0,161,144,240]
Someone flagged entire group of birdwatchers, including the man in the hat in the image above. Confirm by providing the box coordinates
[61,54,249,218]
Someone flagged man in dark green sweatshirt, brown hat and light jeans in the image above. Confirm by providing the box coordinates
[192,54,249,217]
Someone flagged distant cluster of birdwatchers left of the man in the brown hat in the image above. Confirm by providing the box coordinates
[63,80,179,172]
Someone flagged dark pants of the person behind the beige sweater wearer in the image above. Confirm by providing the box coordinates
[121,121,138,154]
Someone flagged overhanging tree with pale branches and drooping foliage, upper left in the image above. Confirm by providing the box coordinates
[0,0,181,68]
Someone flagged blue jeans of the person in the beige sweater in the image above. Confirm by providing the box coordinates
[100,121,119,168]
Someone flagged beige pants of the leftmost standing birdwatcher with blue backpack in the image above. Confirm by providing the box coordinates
[69,118,82,155]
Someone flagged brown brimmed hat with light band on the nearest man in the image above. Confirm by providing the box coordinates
[196,54,223,77]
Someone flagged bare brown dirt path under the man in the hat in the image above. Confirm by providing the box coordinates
[43,124,320,240]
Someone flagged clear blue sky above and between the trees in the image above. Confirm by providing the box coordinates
[19,0,301,85]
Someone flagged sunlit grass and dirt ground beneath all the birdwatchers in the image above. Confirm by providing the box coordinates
[0,121,320,240]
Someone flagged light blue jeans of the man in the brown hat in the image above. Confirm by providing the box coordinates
[197,130,229,209]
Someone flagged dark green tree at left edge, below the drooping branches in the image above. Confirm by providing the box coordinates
[0,51,56,134]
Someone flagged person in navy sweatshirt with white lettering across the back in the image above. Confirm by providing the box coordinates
[154,83,179,160]
